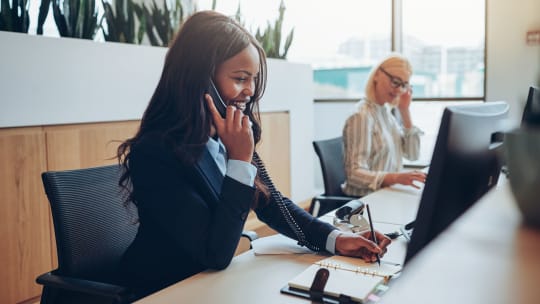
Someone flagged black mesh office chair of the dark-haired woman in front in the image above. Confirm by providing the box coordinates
[36,165,258,304]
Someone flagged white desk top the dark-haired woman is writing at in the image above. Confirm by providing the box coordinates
[137,186,421,304]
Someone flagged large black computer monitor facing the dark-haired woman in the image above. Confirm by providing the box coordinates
[405,102,509,264]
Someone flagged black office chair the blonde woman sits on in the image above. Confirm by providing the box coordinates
[309,136,358,216]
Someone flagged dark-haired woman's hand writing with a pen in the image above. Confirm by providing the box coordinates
[336,231,392,263]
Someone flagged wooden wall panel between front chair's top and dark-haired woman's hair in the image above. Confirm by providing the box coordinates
[44,121,139,170]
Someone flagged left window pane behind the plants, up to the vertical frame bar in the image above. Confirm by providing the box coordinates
[197,0,392,99]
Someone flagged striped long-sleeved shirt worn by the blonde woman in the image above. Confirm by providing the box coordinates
[342,100,423,196]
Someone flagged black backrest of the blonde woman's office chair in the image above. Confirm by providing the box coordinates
[313,136,345,196]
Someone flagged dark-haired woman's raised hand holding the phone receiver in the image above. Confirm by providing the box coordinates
[204,94,255,162]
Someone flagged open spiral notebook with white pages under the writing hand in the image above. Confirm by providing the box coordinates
[281,256,401,303]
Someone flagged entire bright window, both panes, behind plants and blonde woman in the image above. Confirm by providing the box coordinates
[201,0,485,100]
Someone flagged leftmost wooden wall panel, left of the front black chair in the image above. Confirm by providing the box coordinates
[0,127,52,303]
